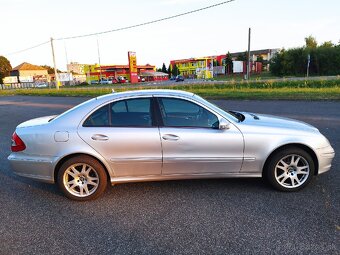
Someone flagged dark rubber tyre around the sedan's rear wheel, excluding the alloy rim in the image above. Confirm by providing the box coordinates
[57,156,107,201]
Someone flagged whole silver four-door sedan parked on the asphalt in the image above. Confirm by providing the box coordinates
[8,90,334,200]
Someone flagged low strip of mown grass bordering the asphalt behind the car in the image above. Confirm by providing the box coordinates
[0,85,340,100]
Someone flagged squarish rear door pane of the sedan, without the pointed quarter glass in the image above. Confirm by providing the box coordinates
[110,98,152,127]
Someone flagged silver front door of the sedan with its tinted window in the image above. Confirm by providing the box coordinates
[158,98,243,175]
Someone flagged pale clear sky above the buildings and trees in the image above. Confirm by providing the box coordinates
[0,0,340,70]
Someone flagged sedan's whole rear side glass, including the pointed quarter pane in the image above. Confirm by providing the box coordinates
[83,98,152,127]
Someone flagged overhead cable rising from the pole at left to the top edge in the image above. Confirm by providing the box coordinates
[55,0,236,40]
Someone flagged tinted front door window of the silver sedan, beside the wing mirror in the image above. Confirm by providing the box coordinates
[159,98,219,128]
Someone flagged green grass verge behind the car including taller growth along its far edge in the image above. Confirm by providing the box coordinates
[0,79,340,100]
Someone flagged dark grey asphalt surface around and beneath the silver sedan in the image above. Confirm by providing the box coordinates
[0,96,340,254]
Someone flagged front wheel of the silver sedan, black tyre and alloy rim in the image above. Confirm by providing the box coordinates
[265,147,315,192]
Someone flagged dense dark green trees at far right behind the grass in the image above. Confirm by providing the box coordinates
[270,36,340,76]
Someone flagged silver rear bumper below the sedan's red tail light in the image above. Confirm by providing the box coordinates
[8,153,57,183]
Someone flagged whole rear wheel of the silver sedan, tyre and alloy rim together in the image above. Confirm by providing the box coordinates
[57,156,107,201]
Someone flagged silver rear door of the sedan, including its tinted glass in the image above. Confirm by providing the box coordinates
[78,97,162,177]
